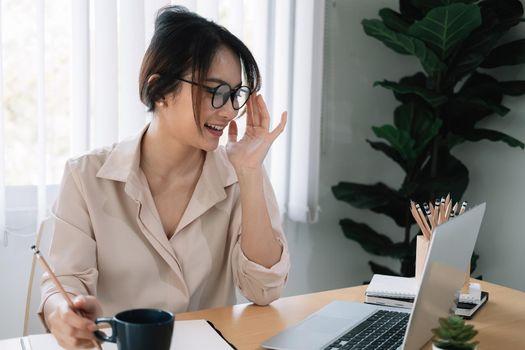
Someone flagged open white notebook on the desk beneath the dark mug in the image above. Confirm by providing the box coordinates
[23,320,232,350]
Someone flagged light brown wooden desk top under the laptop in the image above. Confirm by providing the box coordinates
[176,281,525,350]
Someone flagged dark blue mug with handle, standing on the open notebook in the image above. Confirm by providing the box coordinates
[95,309,175,350]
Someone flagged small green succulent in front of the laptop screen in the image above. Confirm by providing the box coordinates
[432,315,478,350]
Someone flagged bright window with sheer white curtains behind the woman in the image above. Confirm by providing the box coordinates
[0,0,323,246]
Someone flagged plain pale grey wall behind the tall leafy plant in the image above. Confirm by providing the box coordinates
[285,0,525,295]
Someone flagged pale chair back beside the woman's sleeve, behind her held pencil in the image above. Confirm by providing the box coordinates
[24,217,54,336]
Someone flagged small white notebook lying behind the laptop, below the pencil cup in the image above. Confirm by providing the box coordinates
[365,274,419,299]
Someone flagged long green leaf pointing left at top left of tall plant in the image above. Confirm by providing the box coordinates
[362,19,447,75]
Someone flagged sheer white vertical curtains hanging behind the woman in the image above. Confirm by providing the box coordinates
[0,0,324,246]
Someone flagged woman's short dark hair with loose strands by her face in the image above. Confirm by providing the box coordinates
[139,6,261,122]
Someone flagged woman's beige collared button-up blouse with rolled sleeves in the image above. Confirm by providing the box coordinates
[39,127,290,316]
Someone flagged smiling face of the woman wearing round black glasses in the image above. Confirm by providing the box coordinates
[159,47,241,151]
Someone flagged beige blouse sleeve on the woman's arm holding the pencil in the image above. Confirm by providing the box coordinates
[38,161,98,320]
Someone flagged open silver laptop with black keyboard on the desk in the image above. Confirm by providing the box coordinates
[261,203,485,350]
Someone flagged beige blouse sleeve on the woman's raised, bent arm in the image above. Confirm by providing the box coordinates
[232,168,290,305]
